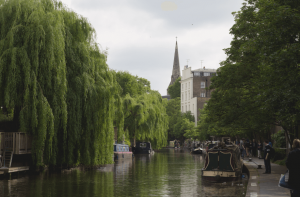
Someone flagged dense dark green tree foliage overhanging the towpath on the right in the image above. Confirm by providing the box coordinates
[200,0,300,143]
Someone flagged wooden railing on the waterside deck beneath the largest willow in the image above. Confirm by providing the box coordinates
[0,132,32,155]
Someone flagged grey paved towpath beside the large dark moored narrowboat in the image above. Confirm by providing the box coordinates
[244,158,290,197]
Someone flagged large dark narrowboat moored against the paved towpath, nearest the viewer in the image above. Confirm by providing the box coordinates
[202,143,243,182]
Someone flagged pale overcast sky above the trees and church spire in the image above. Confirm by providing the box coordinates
[61,0,244,95]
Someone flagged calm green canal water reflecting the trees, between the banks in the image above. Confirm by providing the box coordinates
[0,149,247,197]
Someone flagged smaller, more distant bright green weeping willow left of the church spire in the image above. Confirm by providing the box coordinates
[116,71,169,148]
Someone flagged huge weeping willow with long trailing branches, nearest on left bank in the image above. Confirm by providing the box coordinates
[0,0,122,165]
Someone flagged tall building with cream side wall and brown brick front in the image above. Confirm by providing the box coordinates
[181,66,217,125]
